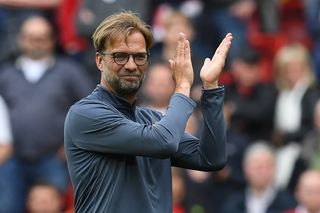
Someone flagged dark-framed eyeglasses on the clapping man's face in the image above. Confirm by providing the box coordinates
[98,51,149,66]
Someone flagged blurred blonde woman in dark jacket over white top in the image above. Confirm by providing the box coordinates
[272,43,319,190]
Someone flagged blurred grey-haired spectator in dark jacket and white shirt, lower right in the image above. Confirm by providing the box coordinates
[222,141,296,213]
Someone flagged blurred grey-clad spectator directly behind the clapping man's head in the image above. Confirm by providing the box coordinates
[75,0,151,82]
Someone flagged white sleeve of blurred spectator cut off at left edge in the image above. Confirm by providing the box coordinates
[0,97,12,145]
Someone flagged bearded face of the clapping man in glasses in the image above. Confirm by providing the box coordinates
[96,32,147,99]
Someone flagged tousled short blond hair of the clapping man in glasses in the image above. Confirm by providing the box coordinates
[92,11,154,52]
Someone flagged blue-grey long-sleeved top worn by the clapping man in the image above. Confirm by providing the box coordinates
[65,85,226,213]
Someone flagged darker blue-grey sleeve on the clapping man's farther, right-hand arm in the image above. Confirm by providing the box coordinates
[171,87,227,171]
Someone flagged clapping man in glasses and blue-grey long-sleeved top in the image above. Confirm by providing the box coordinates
[65,12,232,213]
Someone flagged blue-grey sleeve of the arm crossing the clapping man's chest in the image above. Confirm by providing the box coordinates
[65,93,195,158]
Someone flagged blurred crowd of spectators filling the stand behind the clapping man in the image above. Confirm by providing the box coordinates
[0,0,320,213]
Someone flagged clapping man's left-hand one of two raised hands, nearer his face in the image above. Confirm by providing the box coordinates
[169,33,193,97]
